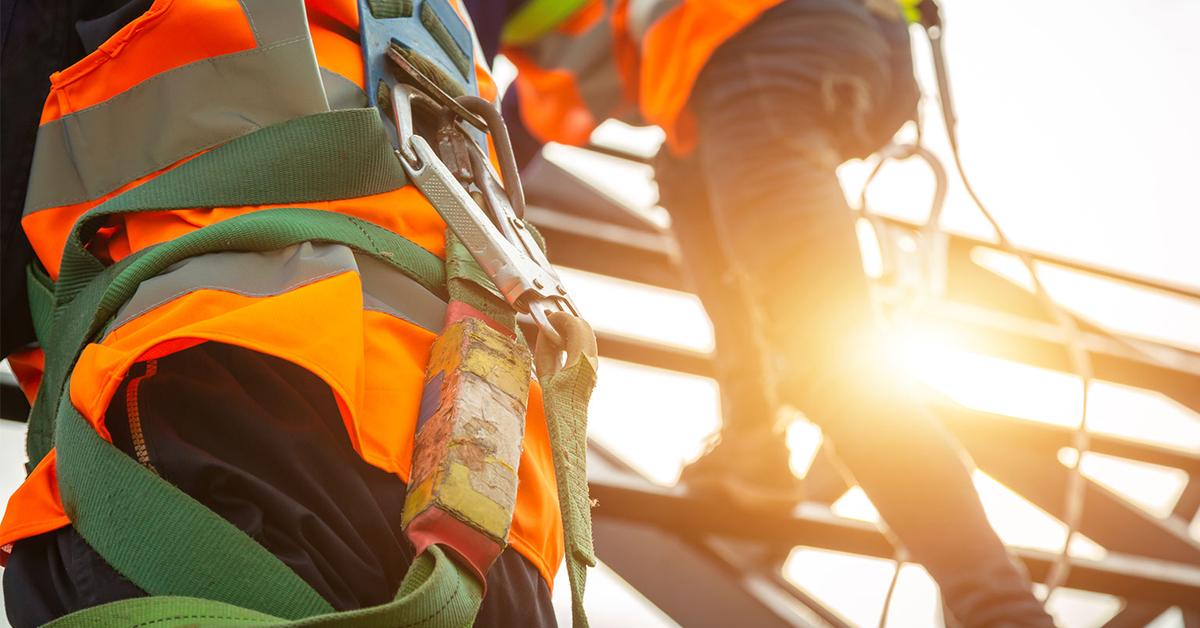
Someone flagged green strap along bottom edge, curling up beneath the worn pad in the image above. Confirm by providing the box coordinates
[47,545,482,628]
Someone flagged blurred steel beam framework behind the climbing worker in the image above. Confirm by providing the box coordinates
[0,149,1200,628]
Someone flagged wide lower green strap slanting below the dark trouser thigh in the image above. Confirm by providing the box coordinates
[58,402,334,618]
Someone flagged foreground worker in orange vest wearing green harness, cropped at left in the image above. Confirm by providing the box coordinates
[0,0,594,627]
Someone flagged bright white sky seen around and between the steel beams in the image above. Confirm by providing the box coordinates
[0,0,1200,628]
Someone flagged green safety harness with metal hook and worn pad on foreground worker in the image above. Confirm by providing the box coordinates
[29,0,596,627]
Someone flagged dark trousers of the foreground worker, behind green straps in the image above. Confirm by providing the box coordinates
[4,342,556,628]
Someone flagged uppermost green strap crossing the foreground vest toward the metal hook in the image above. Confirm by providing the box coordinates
[26,109,408,461]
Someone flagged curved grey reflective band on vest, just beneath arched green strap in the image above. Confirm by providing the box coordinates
[106,243,446,335]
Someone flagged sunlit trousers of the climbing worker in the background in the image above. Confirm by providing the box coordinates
[659,0,1050,626]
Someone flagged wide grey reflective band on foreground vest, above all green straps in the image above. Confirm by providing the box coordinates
[25,0,329,215]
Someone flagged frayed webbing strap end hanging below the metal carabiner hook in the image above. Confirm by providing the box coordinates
[541,359,596,628]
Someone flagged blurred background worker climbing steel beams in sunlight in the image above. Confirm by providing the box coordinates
[481,0,1052,626]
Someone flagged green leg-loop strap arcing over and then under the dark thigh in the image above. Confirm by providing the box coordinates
[42,208,445,618]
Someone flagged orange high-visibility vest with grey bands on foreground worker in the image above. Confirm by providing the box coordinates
[0,0,563,585]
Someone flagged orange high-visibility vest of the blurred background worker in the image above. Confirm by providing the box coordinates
[502,0,782,154]
